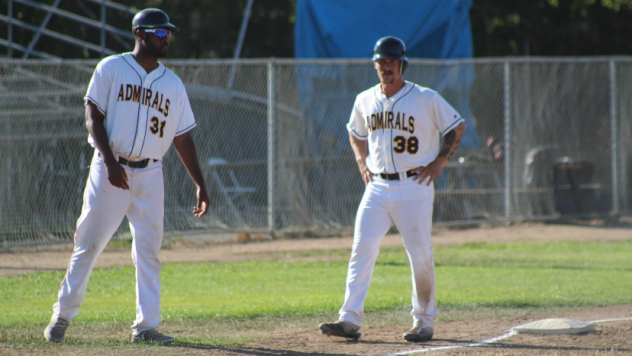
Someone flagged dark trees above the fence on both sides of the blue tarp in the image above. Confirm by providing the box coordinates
[0,0,632,59]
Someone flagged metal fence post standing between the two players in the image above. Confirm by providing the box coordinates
[268,61,277,239]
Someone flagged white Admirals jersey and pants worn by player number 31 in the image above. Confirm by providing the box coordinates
[53,53,196,334]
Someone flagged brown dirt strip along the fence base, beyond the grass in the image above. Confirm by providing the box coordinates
[0,220,632,277]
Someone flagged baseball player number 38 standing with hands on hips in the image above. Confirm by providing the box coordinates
[319,36,465,341]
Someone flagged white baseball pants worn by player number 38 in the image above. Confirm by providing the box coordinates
[339,176,437,326]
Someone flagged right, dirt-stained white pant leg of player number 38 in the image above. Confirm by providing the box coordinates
[391,179,437,326]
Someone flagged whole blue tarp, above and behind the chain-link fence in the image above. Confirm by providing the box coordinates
[295,0,480,149]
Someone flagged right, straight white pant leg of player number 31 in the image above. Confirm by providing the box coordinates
[127,162,164,334]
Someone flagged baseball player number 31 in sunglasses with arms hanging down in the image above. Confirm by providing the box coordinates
[44,9,209,344]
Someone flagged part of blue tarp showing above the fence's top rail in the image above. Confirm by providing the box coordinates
[295,0,472,59]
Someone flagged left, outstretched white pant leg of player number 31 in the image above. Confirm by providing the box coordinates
[53,150,131,320]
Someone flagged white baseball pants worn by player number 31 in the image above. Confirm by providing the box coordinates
[53,150,164,334]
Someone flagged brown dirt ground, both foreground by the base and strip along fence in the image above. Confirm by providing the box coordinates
[0,218,632,355]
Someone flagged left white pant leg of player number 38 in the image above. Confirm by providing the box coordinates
[339,180,393,325]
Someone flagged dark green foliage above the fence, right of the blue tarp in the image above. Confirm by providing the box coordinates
[470,0,632,57]
